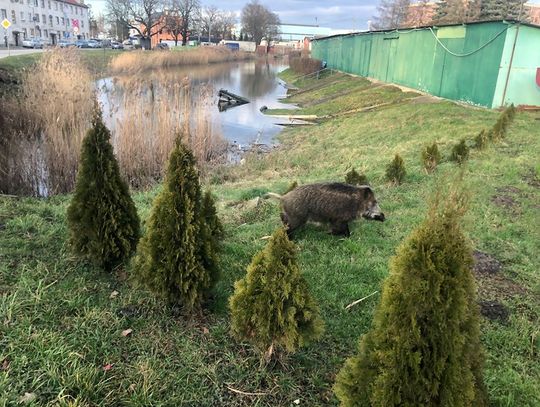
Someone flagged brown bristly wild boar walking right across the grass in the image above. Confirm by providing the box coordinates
[267,182,385,237]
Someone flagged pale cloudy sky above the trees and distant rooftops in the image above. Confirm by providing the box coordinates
[86,0,379,30]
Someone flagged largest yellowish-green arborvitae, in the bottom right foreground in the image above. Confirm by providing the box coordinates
[334,188,487,407]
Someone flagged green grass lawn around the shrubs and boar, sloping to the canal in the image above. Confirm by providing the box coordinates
[0,68,540,407]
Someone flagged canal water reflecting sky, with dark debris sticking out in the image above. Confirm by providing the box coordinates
[97,60,294,150]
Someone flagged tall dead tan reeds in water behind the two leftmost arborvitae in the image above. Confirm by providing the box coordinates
[100,75,226,188]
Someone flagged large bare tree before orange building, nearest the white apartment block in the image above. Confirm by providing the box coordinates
[107,0,163,46]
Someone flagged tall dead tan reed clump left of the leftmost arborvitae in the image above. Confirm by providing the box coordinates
[22,49,94,195]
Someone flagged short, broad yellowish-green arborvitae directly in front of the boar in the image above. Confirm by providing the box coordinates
[229,228,323,359]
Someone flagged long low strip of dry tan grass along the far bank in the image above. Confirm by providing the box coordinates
[110,47,250,74]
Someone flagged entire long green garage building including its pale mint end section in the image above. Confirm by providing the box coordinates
[312,21,540,108]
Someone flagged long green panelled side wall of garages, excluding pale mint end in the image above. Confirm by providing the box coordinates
[312,22,511,107]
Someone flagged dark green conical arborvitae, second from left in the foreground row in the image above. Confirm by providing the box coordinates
[134,141,215,312]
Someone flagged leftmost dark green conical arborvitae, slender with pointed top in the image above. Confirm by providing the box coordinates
[67,107,140,270]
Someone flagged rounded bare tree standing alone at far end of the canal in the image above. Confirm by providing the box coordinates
[242,0,280,45]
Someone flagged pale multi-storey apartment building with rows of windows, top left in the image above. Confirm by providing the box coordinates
[0,0,90,46]
